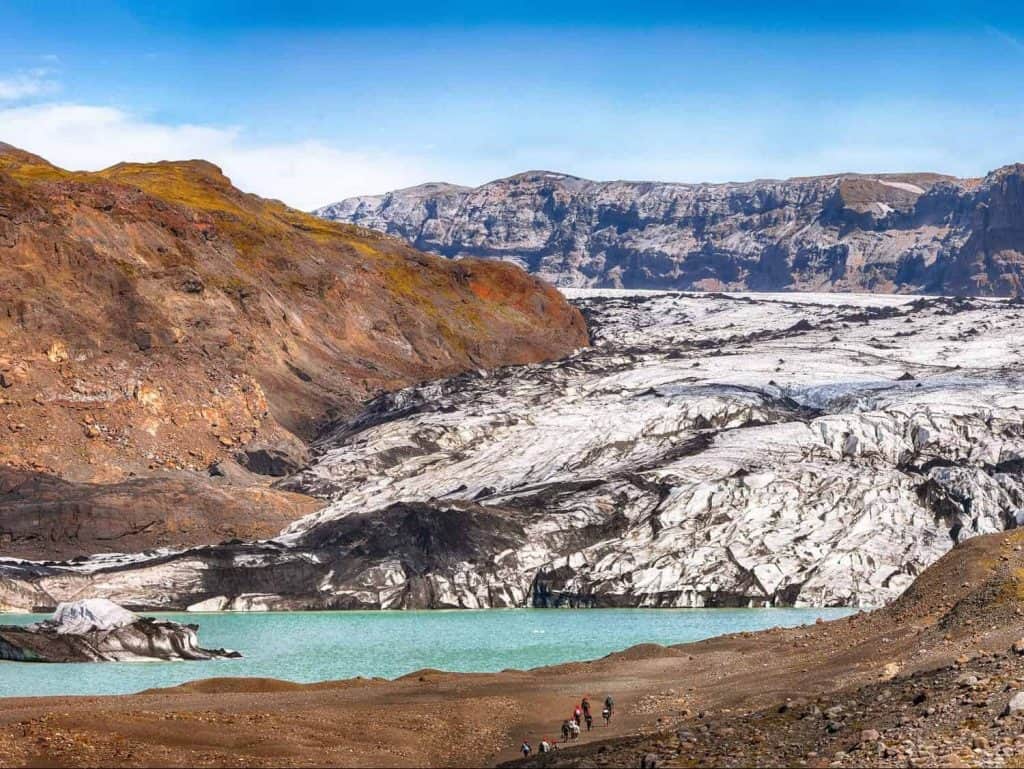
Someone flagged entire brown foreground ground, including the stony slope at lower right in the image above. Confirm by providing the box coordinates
[6,531,1024,766]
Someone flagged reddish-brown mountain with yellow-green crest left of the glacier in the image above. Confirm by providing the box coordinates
[0,144,588,557]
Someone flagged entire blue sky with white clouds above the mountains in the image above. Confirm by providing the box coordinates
[0,0,1024,208]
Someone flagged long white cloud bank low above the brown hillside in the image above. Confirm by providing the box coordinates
[0,102,430,209]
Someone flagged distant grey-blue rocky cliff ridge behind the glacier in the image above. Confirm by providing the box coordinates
[315,165,1024,296]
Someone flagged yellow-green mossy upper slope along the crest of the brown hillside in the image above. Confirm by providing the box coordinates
[0,145,585,370]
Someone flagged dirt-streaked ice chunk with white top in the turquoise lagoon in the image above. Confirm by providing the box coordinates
[0,598,242,663]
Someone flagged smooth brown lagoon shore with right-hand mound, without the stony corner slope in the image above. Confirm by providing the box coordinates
[0,529,1024,766]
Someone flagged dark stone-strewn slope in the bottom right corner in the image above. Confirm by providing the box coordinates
[507,645,1024,767]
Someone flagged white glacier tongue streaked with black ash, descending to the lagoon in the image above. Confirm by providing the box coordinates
[0,291,1024,609]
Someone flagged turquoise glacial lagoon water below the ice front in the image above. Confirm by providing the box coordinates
[0,608,852,696]
